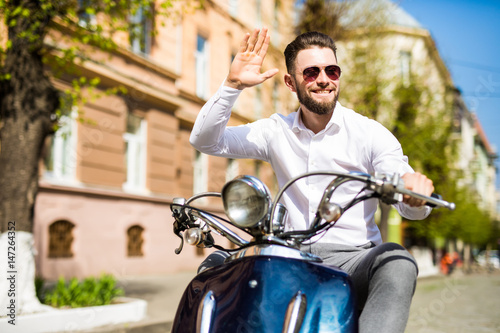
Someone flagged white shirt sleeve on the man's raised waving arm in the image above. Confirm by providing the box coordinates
[189,85,270,161]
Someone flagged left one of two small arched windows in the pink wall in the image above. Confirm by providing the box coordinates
[49,220,75,258]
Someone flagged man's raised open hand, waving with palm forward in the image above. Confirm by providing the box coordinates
[224,28,278,90]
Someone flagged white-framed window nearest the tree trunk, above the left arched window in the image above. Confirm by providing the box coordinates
[44,95,78,181]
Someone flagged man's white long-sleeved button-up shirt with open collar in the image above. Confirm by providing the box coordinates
[190,86,431,246]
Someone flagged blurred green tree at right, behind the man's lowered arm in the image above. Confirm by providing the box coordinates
[393,83,492,245]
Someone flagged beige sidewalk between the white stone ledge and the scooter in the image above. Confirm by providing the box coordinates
[85,271,195,333]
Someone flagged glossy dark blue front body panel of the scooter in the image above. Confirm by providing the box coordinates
[172,256,358,333]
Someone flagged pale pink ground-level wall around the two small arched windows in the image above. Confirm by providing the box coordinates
[34,185,209,280]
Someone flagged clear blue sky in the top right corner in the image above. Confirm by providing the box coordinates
[393,0,500,189]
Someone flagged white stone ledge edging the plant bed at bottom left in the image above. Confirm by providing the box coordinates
[0,297,147,333]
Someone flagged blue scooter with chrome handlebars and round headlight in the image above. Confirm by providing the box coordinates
[171,172,454,333]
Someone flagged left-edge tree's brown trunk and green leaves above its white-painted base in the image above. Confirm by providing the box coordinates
[0,0,202,232]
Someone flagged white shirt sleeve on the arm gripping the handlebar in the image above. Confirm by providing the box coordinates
[372,120,432,220]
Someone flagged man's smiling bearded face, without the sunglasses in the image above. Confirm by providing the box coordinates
[290,48,340,115]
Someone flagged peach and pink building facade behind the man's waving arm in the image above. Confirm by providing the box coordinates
[34,0,296,279]
